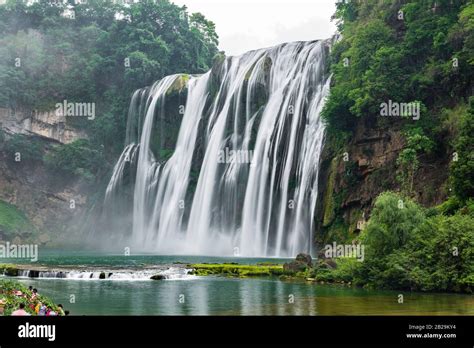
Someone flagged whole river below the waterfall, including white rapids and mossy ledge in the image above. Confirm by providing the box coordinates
[0,251,474,315]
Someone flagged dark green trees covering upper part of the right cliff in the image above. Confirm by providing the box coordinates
[323,0,474,200]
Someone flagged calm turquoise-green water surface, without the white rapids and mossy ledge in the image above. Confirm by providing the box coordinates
[2,252,474,315]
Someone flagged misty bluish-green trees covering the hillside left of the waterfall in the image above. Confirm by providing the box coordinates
[0,0,218,238]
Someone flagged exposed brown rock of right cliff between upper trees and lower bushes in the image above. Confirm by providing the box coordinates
[316,118,450,246]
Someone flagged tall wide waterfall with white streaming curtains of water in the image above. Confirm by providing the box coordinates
[105,41,329,257]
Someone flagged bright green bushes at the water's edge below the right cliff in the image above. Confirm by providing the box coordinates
[310,192,474,293]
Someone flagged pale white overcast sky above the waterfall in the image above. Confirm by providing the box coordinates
[171,0,336,55]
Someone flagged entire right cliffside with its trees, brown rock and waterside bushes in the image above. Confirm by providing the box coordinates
[312,0,474,292]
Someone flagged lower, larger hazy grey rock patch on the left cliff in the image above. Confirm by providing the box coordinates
[0,145,88,246]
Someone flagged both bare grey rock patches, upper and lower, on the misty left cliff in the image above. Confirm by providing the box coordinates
[0,109,91,246]
